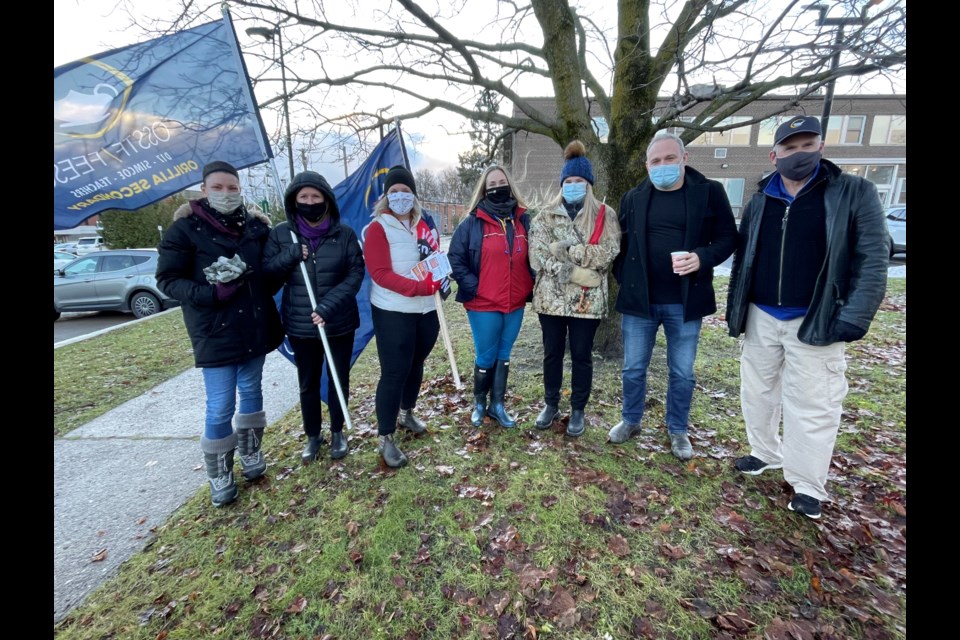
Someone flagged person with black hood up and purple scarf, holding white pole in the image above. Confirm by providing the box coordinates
[264,171,364,464]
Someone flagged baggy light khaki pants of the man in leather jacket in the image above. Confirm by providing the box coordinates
[740,304,847,501]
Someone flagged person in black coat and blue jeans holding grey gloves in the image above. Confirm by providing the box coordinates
[157,161,283,507]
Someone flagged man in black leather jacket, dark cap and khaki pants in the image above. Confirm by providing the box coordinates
[727,116,889,519]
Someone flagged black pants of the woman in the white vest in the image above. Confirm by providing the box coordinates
[371,306,440,436]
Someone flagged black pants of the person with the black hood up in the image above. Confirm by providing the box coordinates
[289,331,354,437]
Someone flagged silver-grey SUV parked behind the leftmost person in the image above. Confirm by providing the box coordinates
[53,249,180,320]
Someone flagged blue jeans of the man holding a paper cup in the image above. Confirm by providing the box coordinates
[620,304,703,432]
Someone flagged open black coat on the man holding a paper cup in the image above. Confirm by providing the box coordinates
[613,167,737,322]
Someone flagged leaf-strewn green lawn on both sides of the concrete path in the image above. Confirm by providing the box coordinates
[55,278,906,640]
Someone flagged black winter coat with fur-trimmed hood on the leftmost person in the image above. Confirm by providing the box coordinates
[157,200,283,367]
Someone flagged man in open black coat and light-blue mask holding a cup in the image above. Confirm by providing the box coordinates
[609,131,737,460]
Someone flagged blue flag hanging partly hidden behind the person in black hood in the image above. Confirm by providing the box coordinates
[275,125,409,404]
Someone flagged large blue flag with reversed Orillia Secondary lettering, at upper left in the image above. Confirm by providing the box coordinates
[53,12,273,229]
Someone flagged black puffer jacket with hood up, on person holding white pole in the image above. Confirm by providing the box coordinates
[263,171,365,338]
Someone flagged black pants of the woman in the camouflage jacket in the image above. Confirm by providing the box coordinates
[537,313,600,410]
